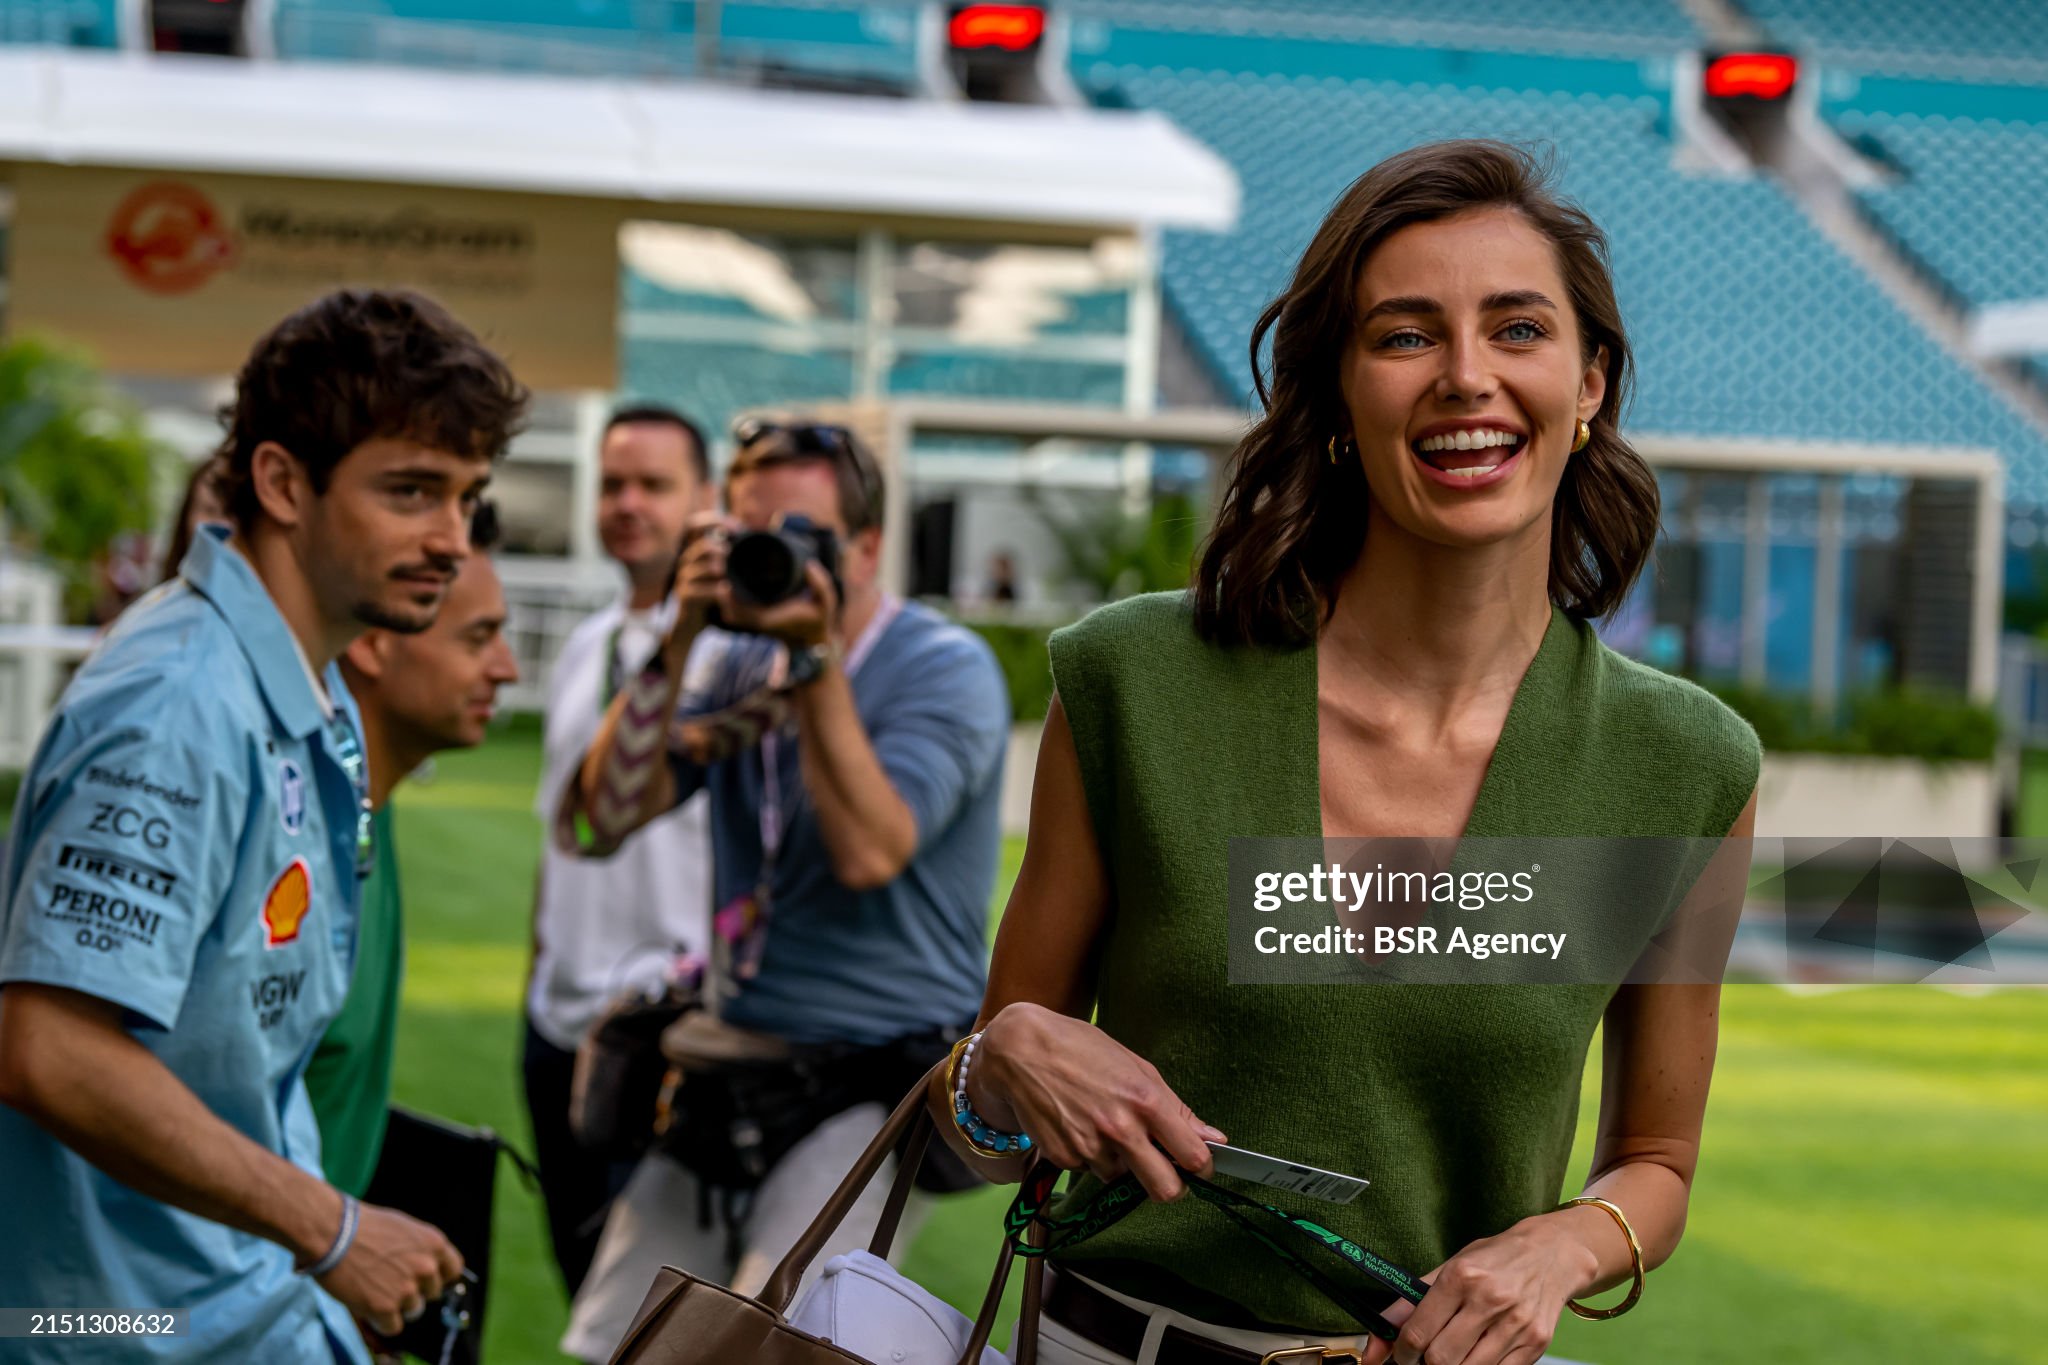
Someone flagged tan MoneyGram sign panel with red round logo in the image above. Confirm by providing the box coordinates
[10,166,618,389]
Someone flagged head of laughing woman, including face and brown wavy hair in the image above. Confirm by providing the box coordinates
[1196,141,1659,643]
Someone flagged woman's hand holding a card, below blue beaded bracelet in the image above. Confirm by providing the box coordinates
[967,1003,1225,1199]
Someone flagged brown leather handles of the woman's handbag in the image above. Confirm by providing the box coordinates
[760,1062,1057,1365]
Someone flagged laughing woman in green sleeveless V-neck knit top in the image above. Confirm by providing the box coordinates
[932,141,1759,1365]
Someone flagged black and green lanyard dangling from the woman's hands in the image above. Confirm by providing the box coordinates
[1004,1162,1430,1340]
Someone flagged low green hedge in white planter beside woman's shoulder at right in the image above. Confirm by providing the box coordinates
[1700,681,1999,763]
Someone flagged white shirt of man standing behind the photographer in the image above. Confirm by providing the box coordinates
[526,602,723,1050]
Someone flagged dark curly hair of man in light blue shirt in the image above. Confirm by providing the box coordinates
[221,289,528,530]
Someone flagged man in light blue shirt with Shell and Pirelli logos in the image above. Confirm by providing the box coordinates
[0,291,526,1361]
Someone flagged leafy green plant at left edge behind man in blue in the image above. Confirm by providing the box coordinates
[0,338,168,612]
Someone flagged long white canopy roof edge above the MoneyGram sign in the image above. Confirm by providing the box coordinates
[0,47,1237,229]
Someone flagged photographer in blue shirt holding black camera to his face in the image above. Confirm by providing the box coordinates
[563,424,1010,1359]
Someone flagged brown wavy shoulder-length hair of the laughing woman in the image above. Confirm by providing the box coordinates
[1194,139,1659,645]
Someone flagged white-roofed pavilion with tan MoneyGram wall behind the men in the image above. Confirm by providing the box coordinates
[0,47,1239,724]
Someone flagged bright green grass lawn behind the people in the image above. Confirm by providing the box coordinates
[397,733,2048,1365]
